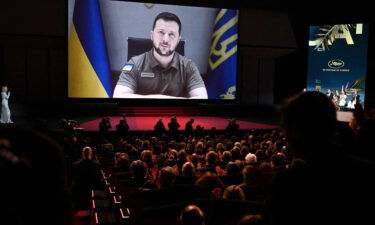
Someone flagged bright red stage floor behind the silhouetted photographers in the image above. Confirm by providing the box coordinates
[78,116,278,131]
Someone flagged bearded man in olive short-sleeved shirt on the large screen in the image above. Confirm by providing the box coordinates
[113,12,207,99]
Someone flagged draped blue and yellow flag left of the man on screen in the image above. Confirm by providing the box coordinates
[68,0,112,98]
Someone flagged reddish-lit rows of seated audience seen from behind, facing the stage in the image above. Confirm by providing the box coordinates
[64,125,284,224]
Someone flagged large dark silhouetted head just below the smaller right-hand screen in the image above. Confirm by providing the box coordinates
[281,91,336,158]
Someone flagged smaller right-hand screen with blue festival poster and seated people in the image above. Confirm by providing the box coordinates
[307,23,368,111]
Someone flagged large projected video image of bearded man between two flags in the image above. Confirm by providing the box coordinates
[68,0,238,99]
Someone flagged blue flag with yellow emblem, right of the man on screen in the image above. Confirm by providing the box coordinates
[206,9,238,99]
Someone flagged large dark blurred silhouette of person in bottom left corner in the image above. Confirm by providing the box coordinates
[0,126,72,225]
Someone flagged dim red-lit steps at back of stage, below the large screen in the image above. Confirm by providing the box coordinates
[117,107,200,116]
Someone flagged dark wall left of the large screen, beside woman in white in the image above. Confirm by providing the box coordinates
[0,0,66,104]
